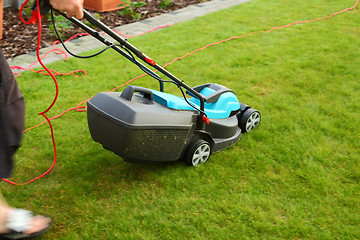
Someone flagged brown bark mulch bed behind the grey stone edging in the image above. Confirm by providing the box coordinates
[0,0,208,59]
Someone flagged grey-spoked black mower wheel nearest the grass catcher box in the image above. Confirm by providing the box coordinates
[185,139,211,166]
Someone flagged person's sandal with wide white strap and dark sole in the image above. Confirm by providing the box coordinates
[0,209,52,239]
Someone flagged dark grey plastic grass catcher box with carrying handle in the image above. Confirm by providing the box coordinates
[87,86,196,162]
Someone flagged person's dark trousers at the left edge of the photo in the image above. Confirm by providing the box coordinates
[0,49,25,178]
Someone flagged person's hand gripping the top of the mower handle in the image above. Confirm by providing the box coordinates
[50,0,84,19]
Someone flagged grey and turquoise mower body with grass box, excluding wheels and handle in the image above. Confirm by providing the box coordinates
[87,84,255,162]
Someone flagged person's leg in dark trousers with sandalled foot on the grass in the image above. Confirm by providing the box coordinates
[0,49,51,239]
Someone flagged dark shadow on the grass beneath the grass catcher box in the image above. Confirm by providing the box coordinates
[61,143,188,185]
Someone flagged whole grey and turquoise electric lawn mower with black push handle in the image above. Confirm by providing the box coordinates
[33,0,261,166]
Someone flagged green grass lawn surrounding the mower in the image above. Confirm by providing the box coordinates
[1,0,360,240]
